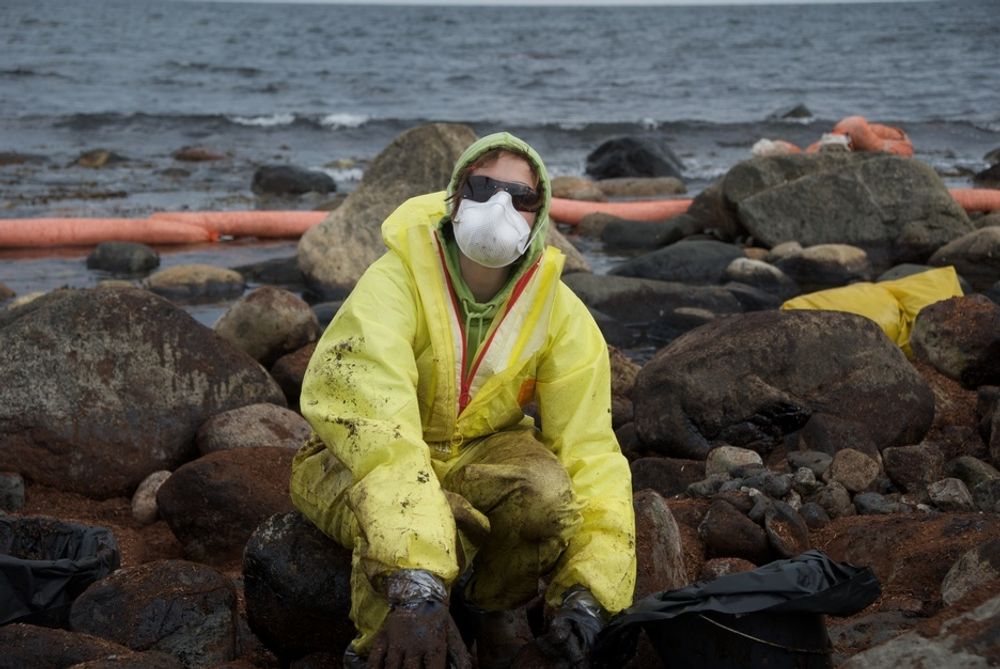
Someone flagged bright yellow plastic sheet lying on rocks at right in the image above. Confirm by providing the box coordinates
[781,266,962,357]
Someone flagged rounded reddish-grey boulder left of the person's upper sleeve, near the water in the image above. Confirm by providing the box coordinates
[212,286,320,367]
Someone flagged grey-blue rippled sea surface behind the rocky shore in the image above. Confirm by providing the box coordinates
[0,0,1000,318]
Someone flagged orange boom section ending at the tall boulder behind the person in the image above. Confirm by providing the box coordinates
[149,210,330,239]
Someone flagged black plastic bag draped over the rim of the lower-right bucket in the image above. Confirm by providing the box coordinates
[595,550,881,666]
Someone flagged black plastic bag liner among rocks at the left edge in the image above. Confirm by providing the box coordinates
[0,516,120,627]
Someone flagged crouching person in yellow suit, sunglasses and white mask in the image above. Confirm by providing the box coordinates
[291,133,636,667]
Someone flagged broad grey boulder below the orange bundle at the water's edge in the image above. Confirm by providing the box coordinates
[689,152,973,267]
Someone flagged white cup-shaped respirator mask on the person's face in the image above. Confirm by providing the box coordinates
[452,190,531,269]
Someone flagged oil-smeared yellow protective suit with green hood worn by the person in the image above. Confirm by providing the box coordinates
[291,134,635,654]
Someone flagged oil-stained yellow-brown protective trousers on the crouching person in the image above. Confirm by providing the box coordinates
[292,428,581,655]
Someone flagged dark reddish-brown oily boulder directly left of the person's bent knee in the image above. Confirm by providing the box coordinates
[156,446,295,564]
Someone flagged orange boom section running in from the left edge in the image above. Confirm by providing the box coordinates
[0,218,219,248]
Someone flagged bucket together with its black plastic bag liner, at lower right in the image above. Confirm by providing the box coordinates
[594,550,881,667]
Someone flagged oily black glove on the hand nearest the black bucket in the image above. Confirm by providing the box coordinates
[536,588,604,669]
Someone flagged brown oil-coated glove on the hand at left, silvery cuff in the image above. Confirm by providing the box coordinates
[367,570,472,669]
